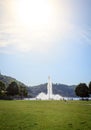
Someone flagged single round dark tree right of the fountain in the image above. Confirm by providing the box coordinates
[75,83,89,98]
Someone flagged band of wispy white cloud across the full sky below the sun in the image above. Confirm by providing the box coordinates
[0,22,91,53]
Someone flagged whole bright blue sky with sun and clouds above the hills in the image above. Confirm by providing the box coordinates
[0,0,91,86]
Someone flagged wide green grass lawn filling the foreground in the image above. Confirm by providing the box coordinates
[0,101,91,130]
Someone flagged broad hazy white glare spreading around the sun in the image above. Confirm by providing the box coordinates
[6,0,70,51]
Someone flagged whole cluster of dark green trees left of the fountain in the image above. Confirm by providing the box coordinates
[0,81,28,99]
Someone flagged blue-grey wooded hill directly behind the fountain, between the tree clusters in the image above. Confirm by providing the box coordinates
[28,83,76,97]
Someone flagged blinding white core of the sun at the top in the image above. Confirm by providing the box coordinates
[12,0,54,28]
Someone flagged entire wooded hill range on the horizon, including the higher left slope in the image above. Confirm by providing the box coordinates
[0,74,76,97]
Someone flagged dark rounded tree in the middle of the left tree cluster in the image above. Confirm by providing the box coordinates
[6,81,19,96]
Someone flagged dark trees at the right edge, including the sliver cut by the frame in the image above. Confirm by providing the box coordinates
[75,81,91,99]
